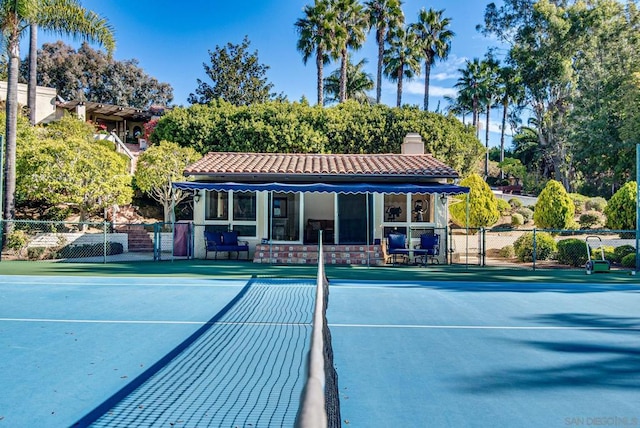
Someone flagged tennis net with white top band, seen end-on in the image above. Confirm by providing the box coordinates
[296,232,341,428]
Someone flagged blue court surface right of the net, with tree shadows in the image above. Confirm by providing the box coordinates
[328,281,640,427]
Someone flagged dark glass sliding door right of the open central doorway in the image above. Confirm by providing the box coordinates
[338,194,373,244]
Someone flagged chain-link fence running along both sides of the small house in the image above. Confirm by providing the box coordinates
[0,220,636,269]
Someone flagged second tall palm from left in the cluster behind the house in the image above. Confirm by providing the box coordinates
[333,0,369,102]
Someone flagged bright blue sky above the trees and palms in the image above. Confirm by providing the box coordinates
[39,0,510,145]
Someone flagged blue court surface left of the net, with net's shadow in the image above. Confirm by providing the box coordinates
[0,277,315,427]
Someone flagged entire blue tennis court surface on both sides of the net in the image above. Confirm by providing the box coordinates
[0,268,640,427]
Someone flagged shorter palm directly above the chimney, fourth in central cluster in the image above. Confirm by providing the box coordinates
[384,28,420,107]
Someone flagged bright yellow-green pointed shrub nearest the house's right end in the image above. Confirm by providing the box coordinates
[449,173,500,228]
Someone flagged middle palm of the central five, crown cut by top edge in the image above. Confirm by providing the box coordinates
[364,0,404,104]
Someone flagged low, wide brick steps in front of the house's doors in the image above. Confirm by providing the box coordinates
[253,244,383,266]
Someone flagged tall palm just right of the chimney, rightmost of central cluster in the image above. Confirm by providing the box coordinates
[410,8,455,111]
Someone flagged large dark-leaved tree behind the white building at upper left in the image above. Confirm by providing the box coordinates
[22,41,173,109]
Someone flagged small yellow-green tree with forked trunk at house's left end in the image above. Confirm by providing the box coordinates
[135,141,201,223]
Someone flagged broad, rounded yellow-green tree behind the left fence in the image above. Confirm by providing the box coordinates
[17,115,133,221]
